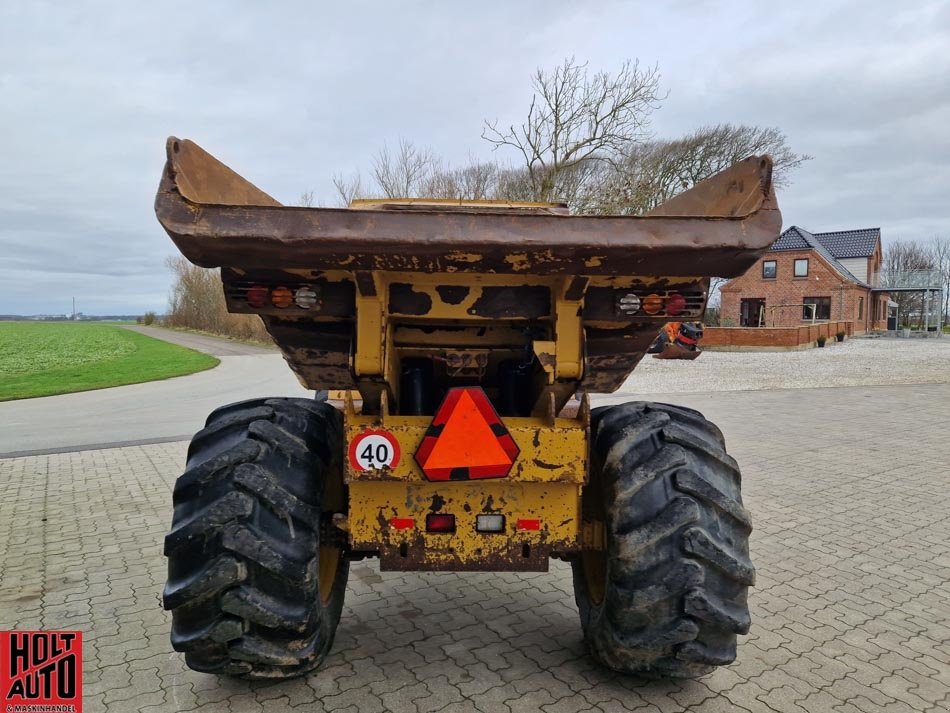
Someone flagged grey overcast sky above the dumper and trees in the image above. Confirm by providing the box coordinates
[0,0,950,314]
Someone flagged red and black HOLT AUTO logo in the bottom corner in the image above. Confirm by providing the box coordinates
[0,631,82,713]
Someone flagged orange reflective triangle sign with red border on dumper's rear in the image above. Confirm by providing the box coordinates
[416,387,518,480]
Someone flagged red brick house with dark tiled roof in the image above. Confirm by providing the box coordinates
[720,225,890,334]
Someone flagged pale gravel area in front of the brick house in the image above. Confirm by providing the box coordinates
[614,337,950,396]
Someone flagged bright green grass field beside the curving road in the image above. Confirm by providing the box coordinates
[0,322,219,401]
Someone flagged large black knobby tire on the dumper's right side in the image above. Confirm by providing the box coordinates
[573,402,755,677]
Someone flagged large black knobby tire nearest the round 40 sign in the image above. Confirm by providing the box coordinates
[164,399,349,678]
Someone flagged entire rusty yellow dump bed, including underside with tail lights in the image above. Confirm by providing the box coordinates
[155,138,781,400]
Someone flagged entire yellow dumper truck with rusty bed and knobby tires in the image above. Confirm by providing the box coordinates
[155,138,781,678]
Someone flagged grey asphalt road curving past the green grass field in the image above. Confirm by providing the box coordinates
[0,327,313,457]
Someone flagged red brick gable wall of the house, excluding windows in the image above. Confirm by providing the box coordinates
[721,250,887,333]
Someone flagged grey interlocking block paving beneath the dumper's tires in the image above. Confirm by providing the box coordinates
[0,385,950,713]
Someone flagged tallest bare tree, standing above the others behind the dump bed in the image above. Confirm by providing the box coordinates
[482,57,663,202]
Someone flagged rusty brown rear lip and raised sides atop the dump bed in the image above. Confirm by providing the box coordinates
[155,137,781,277]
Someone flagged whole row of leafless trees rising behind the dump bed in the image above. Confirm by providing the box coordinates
[324,58,810,214]
